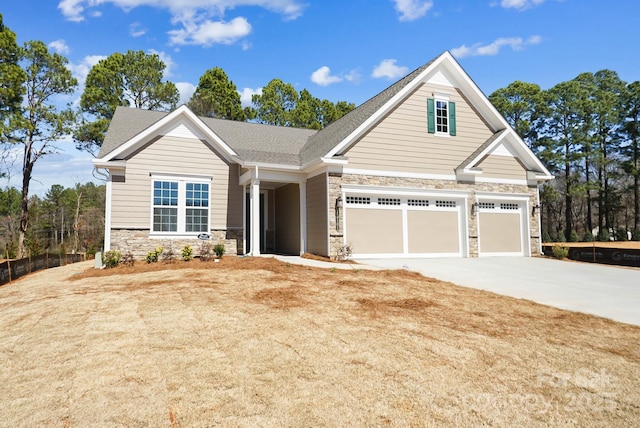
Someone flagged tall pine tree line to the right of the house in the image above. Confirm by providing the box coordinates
[489,70,640,242]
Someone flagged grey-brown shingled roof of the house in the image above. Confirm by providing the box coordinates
[98,55,440,166]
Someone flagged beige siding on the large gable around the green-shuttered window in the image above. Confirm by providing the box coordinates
[346,85,493,175]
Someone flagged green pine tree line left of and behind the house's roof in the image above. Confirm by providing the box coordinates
[0,14,355,257]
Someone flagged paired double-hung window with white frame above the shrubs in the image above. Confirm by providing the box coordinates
[151,177,211,234]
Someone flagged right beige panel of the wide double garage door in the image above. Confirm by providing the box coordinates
[407,211,460,253]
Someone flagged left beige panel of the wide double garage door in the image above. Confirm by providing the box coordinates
[346,208,403,254]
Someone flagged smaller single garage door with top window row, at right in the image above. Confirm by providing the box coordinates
[478,201,525,256]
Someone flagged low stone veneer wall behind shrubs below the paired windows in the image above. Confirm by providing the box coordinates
[111,229,243,260]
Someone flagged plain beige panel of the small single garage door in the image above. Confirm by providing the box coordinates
[479,212,522,253]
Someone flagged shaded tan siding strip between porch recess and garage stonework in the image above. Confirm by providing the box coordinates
[307,174,329,256]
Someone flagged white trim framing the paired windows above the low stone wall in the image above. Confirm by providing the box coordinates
[149,173,213,239]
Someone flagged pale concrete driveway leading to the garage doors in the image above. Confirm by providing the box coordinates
[358,257,640,325]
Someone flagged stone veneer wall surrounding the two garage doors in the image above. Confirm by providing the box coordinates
[329,173,542,257]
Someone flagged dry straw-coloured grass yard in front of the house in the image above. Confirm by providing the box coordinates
[0,258,640,427]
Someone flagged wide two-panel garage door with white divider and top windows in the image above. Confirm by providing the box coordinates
[345,195,464,257]
